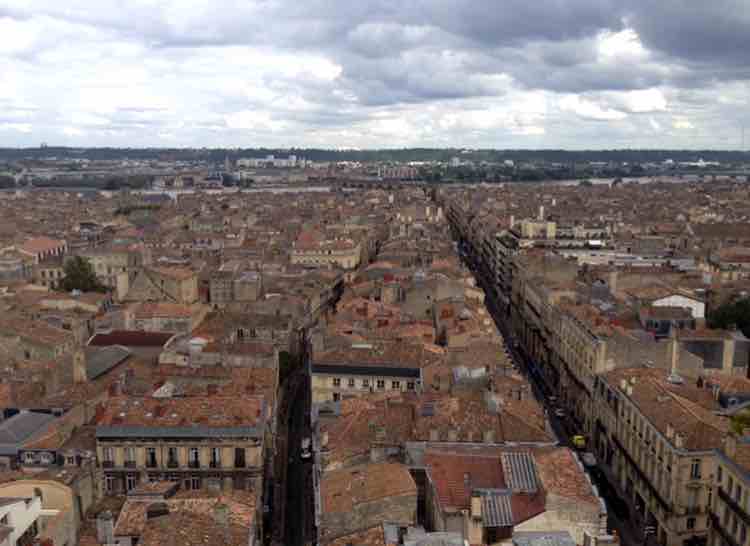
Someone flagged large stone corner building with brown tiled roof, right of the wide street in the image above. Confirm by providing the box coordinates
[593,368,729,546]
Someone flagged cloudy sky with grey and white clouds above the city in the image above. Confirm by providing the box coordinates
[0,0,750,149]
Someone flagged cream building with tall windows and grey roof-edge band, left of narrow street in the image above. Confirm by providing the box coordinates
[96,396,266,494]
